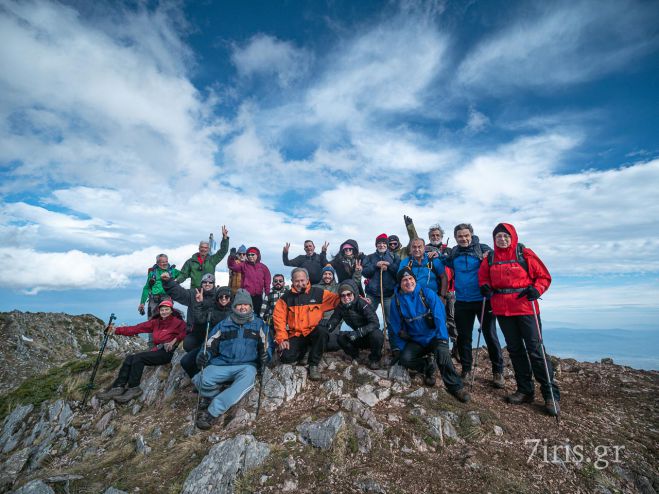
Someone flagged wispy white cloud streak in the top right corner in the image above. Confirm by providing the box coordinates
[458,0,659,92]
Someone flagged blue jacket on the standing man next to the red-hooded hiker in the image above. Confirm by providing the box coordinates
[444,239,492,302]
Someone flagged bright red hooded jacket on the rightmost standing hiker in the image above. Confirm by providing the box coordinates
[478,223,551,316]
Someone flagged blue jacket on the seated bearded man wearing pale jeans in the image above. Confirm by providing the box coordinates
[202,316,274,367]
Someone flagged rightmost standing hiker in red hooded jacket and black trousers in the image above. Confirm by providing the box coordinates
[478,223,560,416]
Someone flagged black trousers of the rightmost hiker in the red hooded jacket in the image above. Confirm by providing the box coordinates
[497,315,560,401]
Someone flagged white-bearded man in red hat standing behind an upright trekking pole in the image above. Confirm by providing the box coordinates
[362,233,400,329]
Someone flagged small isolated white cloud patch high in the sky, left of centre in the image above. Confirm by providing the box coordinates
[231,34,312,87]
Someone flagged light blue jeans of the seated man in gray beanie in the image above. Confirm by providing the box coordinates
[192,364,256,417]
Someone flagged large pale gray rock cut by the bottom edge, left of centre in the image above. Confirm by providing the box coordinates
[181,435,270,494]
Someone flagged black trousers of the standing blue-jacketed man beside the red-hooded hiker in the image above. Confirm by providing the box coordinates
[455,300,503,374]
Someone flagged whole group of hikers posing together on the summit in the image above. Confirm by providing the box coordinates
[98,216,560,429]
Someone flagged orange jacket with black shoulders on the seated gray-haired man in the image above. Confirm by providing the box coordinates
[272,284,339,345]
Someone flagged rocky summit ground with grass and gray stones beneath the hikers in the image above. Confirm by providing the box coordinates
[0,312,659,494]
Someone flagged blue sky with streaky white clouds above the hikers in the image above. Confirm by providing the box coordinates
[0,0,659,336]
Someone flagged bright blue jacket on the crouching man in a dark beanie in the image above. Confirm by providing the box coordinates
[388,283,448,350]
